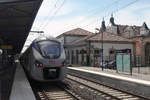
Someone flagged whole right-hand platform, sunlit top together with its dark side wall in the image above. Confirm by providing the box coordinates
[68,67,150,99]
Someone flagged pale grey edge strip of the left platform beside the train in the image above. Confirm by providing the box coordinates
[10,63,36,100]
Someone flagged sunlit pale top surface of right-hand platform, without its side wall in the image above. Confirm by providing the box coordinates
[68,66,150,85]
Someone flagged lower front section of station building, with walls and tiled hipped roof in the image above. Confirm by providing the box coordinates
[66,32,135,66]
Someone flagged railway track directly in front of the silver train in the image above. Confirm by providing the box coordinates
[36,84,82,100]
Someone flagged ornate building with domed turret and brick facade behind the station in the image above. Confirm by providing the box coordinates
[106,16,150,66]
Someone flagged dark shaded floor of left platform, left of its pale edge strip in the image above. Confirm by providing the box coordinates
[0,63,16,100]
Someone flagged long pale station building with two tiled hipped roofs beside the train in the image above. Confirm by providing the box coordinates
[57,21,135,66]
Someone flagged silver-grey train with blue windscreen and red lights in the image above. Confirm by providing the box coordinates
[20,36,66,82]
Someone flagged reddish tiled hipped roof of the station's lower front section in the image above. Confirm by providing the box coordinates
[87,32,134,42]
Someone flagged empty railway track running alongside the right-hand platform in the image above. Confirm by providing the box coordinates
[66,74,147,100]
